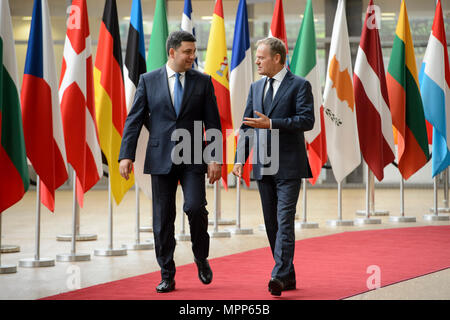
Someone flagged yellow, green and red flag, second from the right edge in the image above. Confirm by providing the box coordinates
[386,0,430,180]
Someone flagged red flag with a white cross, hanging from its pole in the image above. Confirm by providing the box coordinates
[59,0,103,207]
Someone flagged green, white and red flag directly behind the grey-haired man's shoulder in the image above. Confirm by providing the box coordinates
[291,0,327,184]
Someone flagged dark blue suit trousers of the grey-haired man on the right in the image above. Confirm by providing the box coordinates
[258,176,301,280]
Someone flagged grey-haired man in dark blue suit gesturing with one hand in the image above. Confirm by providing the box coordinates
[233,38,314,296]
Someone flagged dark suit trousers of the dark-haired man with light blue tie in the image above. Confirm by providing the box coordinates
[152,165,209,279]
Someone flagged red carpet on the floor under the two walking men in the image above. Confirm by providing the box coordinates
[45,226,450,300]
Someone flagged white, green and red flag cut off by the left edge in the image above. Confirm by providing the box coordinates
[0,0,30,214]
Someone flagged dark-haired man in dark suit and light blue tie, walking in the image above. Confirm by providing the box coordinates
[119,31,222,292]
